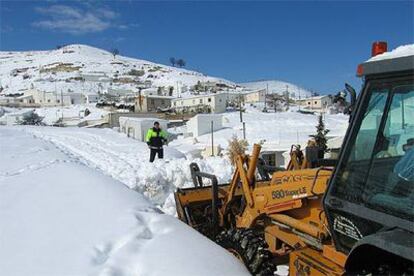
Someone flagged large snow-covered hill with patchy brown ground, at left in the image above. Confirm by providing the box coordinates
[0,44,235,94]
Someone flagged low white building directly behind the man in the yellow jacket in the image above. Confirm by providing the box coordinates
[119,117,168,142]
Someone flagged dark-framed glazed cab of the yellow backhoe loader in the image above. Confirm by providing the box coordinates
[324,45,414,274]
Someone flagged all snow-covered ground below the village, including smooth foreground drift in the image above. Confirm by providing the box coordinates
[0,107,348,275]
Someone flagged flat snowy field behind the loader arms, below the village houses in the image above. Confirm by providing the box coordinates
[170,107,349,155]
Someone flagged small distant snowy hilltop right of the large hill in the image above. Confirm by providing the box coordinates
[240,80,311,98]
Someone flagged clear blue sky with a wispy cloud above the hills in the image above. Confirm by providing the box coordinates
[0,0,414,93]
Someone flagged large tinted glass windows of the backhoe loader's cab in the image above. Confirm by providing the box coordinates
[333,83,414,219]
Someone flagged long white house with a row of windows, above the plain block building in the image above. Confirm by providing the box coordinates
[171,93,228,113]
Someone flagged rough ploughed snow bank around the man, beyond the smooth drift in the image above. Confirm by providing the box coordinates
[20,127,232,214]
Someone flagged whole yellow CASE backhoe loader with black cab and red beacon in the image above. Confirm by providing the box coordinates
[175,43,414,275]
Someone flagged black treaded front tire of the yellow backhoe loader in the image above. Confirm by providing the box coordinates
[216,229,276,276]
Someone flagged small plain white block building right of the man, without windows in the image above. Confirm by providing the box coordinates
[187,114,223,137]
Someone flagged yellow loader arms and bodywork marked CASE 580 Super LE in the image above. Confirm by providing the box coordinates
[175,145,346,275]
